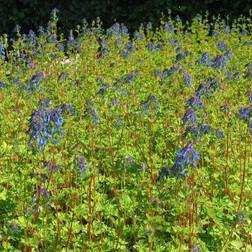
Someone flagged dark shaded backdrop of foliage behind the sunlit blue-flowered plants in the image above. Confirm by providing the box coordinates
[0,0,252,35]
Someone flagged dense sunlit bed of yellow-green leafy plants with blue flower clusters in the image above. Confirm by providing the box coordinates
[0,14,252,251]
